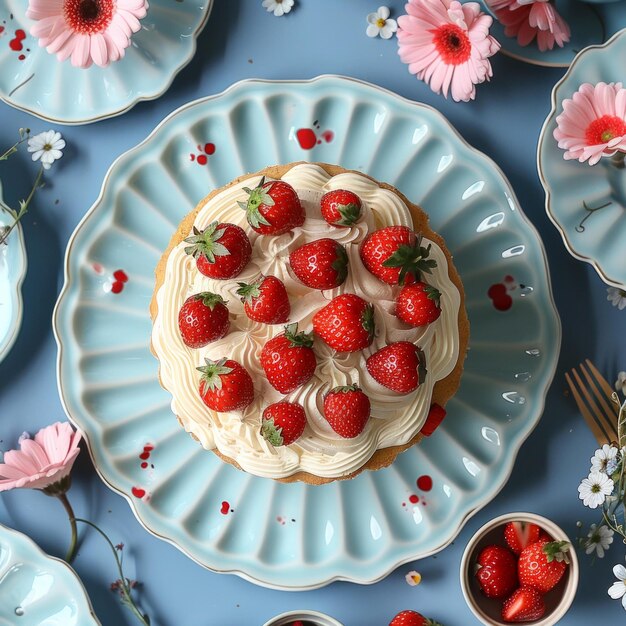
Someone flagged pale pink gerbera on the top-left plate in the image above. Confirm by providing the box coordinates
[26,0,148,67]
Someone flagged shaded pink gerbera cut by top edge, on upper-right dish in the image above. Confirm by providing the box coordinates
[489,0,571,52]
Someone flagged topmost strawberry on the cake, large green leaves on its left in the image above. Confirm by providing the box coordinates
[238,177,305,235]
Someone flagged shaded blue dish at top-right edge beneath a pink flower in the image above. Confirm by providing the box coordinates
[480,0,626,67]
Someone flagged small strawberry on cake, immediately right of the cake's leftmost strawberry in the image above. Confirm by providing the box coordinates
[237,276,291,324]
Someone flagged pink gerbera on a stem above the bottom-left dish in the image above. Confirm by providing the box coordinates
[0,422,80,493]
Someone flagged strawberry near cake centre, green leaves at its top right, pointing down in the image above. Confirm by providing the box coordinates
[261,324,317,393]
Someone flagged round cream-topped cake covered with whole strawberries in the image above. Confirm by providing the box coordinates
[151,163,469,484]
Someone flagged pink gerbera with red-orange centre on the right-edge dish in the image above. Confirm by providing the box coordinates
[554,83,626,165]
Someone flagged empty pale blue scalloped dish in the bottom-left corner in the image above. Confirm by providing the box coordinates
[0,525,100,626]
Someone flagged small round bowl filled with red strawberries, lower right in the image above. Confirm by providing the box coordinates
[461,513,578,626]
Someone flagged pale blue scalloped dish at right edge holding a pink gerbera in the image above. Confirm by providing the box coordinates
[537,30,626,289]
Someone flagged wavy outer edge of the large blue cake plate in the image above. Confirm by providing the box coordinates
[52,74,562,591]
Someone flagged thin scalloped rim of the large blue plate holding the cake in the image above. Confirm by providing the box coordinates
[53,74,562,591]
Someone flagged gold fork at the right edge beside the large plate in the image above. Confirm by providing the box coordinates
[565,359,619,445]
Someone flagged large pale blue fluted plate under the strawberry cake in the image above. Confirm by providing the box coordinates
[54,76,560,589]
